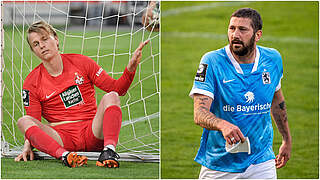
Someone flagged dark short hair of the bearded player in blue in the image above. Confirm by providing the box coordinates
[231,8,262,32]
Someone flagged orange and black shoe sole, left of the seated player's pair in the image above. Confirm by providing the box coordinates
[62,152,88,168]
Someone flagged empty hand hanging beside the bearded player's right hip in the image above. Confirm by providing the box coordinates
[275,141,291,169]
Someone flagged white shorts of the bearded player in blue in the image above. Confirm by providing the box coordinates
[199,159,277,179]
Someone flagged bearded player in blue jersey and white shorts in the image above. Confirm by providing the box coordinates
[190,8,292,179]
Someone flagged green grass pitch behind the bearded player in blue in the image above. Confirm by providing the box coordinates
[161,1,319,179]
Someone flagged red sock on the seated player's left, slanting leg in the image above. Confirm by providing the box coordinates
[25,126,67,159]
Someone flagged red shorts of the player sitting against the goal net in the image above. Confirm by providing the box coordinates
[50,121,103,152]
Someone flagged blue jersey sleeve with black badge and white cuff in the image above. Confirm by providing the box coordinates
[189,54,215,99]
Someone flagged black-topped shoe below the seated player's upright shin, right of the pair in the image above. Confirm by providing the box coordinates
[96,148,120,168]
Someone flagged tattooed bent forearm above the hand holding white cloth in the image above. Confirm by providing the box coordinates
[194,96,221,130]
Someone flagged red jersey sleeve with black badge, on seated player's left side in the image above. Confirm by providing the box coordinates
[22,84,42,121]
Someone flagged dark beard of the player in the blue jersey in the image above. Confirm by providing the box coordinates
[229,34,255,56]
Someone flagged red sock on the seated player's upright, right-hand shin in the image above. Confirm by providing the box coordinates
[103,105,122,147]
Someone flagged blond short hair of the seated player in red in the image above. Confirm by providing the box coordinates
[27,21,59,50]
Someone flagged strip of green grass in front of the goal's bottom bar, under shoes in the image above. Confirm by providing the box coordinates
[1,159,159,179]
